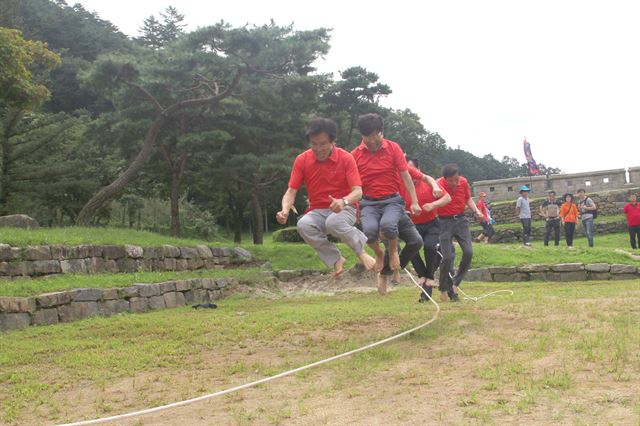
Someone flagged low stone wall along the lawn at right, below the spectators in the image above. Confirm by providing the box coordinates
[465,263,640,282]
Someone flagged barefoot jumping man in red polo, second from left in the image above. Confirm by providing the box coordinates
[351,114,422,276]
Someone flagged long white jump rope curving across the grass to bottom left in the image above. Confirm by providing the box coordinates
[61,270,440,426]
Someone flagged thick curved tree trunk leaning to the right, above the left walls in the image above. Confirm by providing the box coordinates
[77,114,166,226]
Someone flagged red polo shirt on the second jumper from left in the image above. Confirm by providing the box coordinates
[351,139,407,198]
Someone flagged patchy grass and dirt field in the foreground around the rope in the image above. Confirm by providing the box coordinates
[0,281,640,425]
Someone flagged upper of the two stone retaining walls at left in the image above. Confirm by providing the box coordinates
[0,244,251,285]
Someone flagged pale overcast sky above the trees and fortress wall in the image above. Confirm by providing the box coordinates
[76,0,640,173]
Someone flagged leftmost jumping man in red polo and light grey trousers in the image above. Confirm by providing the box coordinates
[276,118,375,277]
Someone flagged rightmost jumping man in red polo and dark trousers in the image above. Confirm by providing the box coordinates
[437,164,483,301]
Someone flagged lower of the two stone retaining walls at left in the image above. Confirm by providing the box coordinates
[0,278,233,330]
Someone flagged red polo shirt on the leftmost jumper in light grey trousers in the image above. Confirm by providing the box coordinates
[289,147,362,211]
